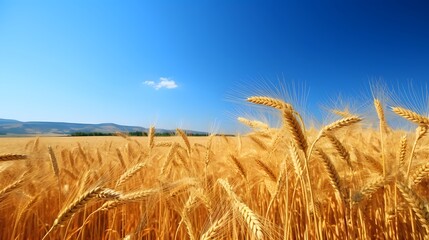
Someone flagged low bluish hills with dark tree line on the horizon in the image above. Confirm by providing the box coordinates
[0,118,203,135]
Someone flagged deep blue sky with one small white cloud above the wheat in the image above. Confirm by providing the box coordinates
[0,0,429,131]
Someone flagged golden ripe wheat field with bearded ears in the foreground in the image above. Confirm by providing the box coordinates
[0,96,429,239]
